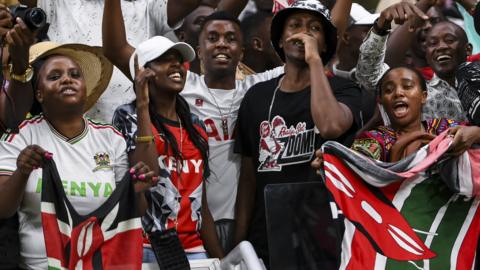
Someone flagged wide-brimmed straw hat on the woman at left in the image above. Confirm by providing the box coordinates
[29,41,113,111]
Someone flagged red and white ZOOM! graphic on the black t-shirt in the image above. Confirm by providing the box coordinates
[258,115,315,172]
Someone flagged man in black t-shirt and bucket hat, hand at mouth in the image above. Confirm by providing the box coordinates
[235,0,360,264]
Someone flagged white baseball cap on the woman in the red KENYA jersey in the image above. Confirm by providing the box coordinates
[129,36,195,78]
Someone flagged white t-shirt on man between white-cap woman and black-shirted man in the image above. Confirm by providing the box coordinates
[181,67,283,221]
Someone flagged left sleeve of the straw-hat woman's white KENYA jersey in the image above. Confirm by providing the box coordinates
[0,133,28,175]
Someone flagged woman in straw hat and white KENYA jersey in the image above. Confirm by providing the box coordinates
[0,42,153,269]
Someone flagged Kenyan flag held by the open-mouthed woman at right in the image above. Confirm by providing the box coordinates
[322,134,480,270]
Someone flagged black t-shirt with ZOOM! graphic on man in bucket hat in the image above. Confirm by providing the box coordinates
[235,77,361,264]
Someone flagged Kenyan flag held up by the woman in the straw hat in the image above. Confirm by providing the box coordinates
[41,160,143,270]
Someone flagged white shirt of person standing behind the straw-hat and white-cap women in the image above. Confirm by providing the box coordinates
[37,0,175,123]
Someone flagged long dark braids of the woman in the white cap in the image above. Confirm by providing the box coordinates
[149,94,210,179]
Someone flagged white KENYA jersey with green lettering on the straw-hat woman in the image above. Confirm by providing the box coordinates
[0,116,128,270]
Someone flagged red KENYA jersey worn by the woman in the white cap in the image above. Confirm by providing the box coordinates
[113,103,210,252]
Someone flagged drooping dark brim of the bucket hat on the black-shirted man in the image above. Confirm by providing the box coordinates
[270,7,337,64]
